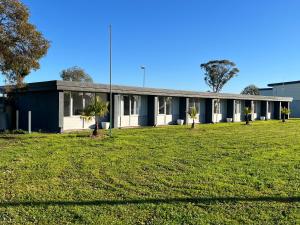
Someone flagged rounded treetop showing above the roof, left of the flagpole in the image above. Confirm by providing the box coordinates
[60,66,93,83]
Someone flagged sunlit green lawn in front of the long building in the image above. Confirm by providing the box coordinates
[0,120,300,224]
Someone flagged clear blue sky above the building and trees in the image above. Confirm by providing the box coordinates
[2,0,300,92]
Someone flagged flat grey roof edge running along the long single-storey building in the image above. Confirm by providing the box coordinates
[2,80,293,102]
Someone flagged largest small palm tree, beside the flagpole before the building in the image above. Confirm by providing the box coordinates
[81,98,108,136]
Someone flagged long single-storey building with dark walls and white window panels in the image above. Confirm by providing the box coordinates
[0,81,293,132]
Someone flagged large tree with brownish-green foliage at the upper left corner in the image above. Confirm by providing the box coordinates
[0,0,50,86]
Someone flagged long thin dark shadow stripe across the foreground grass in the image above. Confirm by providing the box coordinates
[0,196,300,207]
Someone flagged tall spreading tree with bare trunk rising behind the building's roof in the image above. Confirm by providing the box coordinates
[200,60,239,93]
